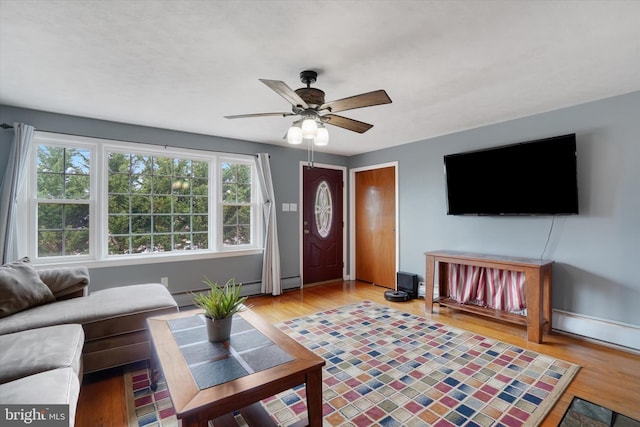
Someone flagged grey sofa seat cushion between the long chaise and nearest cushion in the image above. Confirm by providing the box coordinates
[0,325,84,384]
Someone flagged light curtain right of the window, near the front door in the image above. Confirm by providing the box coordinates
[256,153,282,295]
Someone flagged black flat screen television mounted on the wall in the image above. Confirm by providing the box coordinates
[444,134,578,215]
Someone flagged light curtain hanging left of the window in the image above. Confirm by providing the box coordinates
[0,123,35,264]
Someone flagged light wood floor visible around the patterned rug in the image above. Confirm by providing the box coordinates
[76,282,640,427]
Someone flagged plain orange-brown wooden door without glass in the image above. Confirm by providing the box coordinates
[355,166,396,289]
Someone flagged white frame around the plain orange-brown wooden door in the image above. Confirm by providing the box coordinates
[348,161,400,280]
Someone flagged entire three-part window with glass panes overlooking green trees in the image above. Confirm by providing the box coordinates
[25,132,262,263]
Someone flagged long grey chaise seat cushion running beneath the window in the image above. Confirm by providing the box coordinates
[0,283,177,340]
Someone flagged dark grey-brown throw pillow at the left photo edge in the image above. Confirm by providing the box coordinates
[0,257,55,318]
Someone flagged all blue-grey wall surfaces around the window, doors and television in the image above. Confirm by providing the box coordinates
[0,92,640,325]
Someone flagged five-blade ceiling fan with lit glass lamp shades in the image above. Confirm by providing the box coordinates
[225,70,391,145]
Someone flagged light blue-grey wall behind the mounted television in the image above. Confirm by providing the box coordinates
[349,92,640,325]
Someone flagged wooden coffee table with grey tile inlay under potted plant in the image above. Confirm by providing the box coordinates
[147,310,325,427]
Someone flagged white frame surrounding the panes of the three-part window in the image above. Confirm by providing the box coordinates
[18,131,263,267]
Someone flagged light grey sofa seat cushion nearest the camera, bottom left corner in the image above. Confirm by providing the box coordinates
[0,368,80,427]
